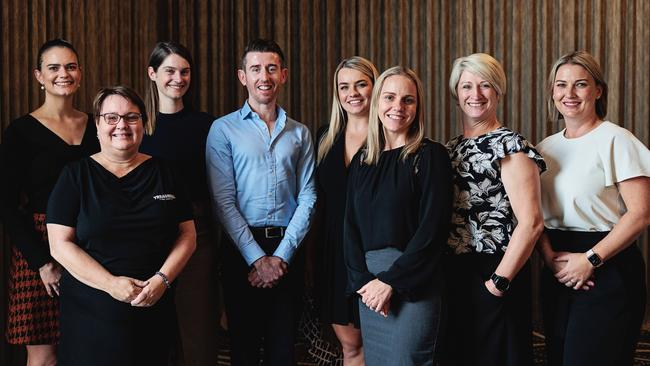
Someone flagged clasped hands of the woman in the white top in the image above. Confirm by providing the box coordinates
[544,252,595,291]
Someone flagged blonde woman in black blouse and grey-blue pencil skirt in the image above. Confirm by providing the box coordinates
[344,66,452,365]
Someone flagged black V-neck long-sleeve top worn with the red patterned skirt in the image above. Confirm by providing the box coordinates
[0,114,99,271]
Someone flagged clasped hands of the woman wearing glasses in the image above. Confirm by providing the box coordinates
[107,275,167,307]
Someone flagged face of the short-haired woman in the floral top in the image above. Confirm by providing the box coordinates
[456,70,499,122]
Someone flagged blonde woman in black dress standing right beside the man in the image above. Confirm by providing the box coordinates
[316,56,378,366]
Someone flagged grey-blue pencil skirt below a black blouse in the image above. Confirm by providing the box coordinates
[359,248,442,366]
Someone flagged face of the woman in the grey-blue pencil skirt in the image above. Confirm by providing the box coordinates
[377,75,418,138]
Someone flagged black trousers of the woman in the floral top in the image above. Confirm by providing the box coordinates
[441,253,533,366]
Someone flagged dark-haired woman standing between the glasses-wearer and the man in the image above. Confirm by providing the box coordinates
[140,42,219,365]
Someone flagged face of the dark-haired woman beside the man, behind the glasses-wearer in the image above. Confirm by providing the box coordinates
[147,53,191,100]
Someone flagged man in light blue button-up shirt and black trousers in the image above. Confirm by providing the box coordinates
[206,39,316,365]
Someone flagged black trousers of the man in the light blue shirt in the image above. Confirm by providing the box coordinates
[221,233,304,366]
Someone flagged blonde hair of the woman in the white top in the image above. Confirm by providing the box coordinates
[546,51,609,122]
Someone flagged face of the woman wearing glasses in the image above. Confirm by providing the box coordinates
[96,95,144,156]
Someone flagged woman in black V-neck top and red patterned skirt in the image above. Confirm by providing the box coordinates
[2,39,99,365]
